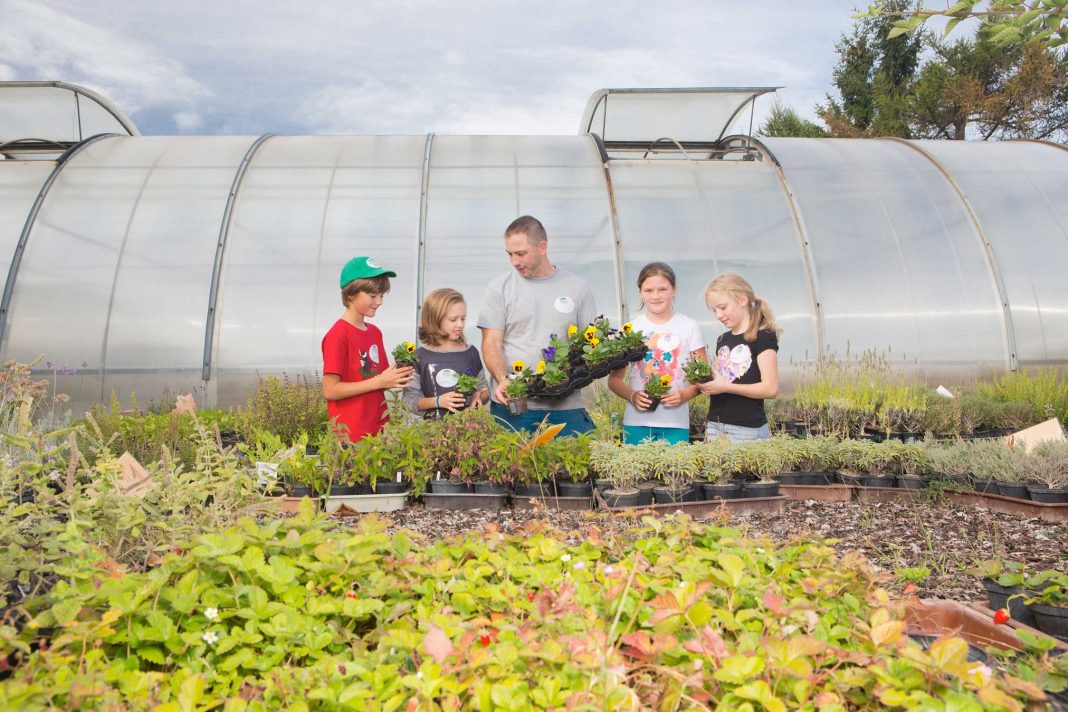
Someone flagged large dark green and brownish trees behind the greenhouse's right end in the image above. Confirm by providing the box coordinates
[818,1,1068,141]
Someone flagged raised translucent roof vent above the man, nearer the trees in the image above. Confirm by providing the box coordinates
[579,86,782,159]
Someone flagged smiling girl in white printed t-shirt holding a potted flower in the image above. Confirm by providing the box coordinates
[608,262,708,444]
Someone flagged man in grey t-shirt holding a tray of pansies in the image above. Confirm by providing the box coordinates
[478,216,597,434]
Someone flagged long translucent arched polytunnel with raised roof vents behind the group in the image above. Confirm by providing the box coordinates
[0,82,1068,407]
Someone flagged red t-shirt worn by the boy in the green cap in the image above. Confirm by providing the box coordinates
[323,319,389,442]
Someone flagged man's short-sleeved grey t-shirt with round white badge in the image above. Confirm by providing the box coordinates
[478,268,597,410]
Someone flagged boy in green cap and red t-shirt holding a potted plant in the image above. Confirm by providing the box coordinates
[323,257,414,442]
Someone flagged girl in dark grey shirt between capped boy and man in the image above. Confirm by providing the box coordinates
[404,288,489,417]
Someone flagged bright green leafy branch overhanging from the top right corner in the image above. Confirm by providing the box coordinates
[858,0,1068,49]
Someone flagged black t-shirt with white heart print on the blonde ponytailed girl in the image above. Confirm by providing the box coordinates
[708,329,779,428]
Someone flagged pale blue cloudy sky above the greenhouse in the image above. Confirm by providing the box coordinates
[0,0,867,135]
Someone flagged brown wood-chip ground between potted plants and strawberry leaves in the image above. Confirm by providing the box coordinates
[345,502,1068,601]
